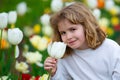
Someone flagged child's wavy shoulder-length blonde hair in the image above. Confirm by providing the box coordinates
[50,2,106,54]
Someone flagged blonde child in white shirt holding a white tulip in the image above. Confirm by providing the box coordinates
[44,2,120,80]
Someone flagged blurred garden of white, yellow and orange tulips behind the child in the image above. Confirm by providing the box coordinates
[0,0,120,80]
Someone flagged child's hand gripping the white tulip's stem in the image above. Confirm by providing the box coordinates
[44,57,57,76]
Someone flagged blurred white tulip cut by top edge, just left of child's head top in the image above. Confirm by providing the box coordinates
[51,0,63,12]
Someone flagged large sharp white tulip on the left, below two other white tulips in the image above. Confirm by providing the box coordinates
[8,28,23,45]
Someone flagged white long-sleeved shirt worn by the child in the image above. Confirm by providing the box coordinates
[51,39,120,80]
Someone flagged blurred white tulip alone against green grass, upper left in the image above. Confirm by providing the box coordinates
[17,2,27,16]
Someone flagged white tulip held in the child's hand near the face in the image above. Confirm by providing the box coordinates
[47,42,66,59]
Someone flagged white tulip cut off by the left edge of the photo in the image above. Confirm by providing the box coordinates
[0,12,8,29]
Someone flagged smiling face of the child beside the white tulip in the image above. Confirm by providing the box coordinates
[58,19,88,50]
